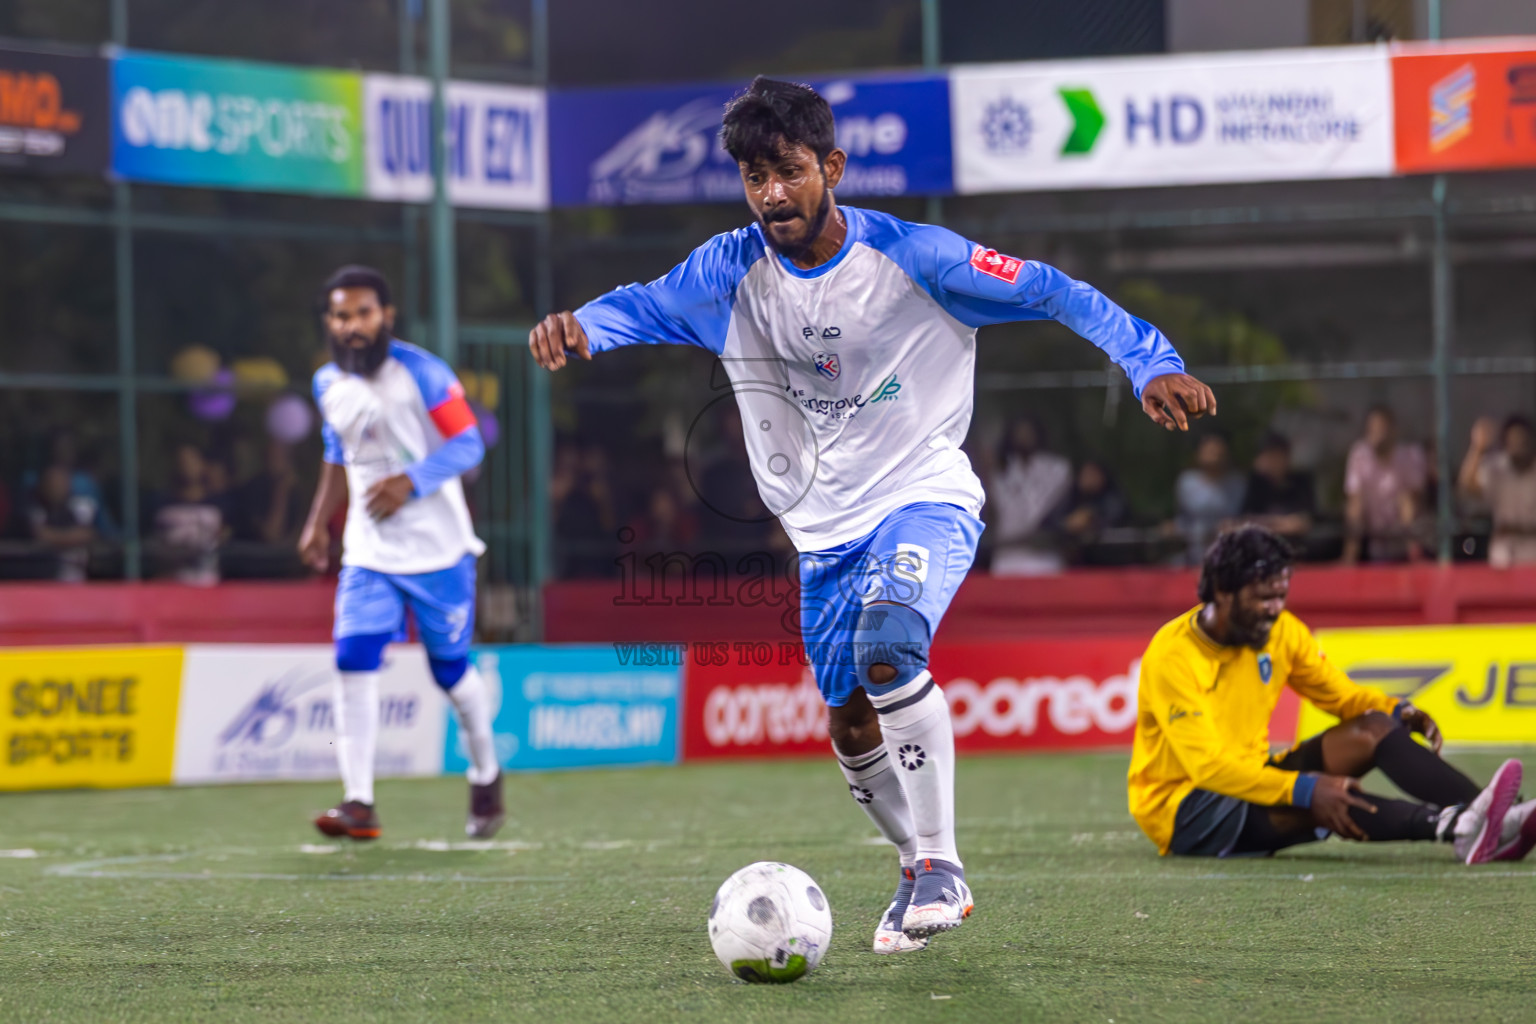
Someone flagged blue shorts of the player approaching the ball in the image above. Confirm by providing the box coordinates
[800,502,985,708]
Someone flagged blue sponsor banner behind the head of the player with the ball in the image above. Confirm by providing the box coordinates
[550,75,954,206]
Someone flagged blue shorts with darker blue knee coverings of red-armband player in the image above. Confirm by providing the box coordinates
[333,554,475,689]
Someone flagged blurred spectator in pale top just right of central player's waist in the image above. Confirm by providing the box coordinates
[986,416,1072,576]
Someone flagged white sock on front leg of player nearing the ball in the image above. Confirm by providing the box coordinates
[869,671,963,866]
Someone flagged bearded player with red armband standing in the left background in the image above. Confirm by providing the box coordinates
[300,267,505,840]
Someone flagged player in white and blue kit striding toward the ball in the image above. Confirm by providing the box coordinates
[528,78,1217,953]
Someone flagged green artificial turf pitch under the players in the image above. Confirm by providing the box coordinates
[0,754,1536,1024]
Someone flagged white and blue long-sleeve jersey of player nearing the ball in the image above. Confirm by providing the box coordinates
[576,206,1184,551]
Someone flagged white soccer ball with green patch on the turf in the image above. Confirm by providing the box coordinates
[710,861,833,983]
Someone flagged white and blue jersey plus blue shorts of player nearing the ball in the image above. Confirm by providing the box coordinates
[576,206,1184,706]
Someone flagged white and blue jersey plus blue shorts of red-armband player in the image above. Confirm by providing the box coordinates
[315,341,485,688]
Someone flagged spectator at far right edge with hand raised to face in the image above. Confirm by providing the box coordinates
[1456,416,1536,568]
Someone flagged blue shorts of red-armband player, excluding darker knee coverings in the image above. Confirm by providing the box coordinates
[332,554,475,660]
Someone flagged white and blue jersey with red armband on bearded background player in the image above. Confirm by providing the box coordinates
[315,341,485,576]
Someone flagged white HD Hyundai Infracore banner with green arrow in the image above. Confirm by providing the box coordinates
[949,48,1393,193]
